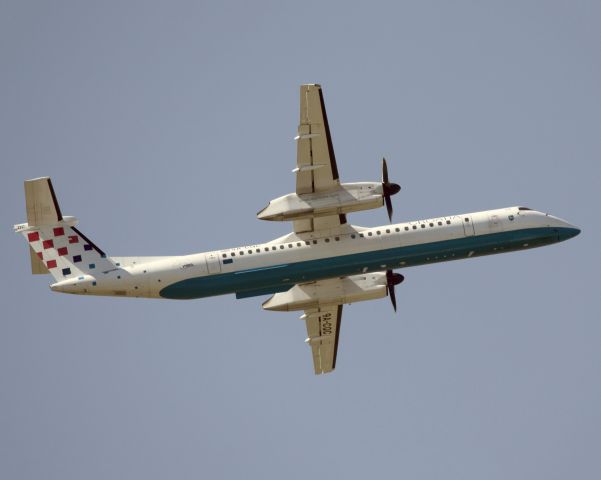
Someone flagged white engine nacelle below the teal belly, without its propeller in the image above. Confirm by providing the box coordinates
[263,272,388,312]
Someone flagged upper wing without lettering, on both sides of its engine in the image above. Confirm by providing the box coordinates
[294,84,346,233]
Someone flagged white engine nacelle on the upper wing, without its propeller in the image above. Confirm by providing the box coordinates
[257,182,384,221]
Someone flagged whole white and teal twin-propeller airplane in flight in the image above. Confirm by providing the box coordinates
[14,84,580,374]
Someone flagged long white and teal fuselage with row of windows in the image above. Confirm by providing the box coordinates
[51,207,579,299]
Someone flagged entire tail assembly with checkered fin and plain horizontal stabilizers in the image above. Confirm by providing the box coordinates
[14,177,115,282]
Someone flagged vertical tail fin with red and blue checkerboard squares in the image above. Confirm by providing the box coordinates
[23,226,114,281]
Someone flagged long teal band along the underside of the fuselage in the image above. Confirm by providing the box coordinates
[160,227,578,299]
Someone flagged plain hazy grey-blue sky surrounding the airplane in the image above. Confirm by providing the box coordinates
[0,1,601,480]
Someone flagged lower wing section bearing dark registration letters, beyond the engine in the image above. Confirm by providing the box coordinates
[305,305,342,375]
